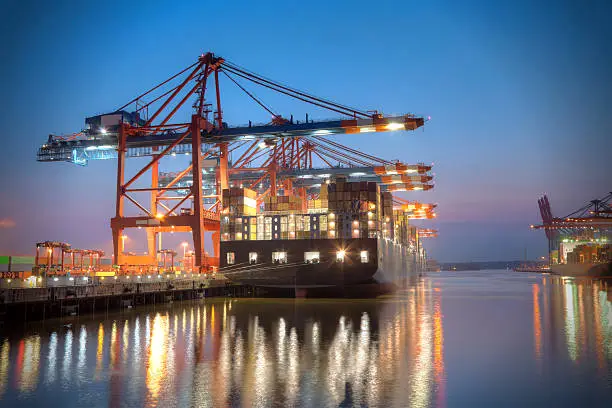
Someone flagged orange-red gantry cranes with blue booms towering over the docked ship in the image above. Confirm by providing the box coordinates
[37,53,432,269]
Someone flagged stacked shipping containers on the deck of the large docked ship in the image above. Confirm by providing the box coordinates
[221,178,418,244]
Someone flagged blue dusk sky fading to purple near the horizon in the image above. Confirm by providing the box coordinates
[0,0,612,261]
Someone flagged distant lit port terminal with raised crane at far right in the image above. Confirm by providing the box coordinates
[531,193,612,277]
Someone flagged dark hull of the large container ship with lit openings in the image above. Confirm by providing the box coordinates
[220,238,422,289]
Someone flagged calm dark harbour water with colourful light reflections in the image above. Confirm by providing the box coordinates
[0,272,612,407]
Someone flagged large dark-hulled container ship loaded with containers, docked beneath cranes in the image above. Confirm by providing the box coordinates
[220,175,427,289]
